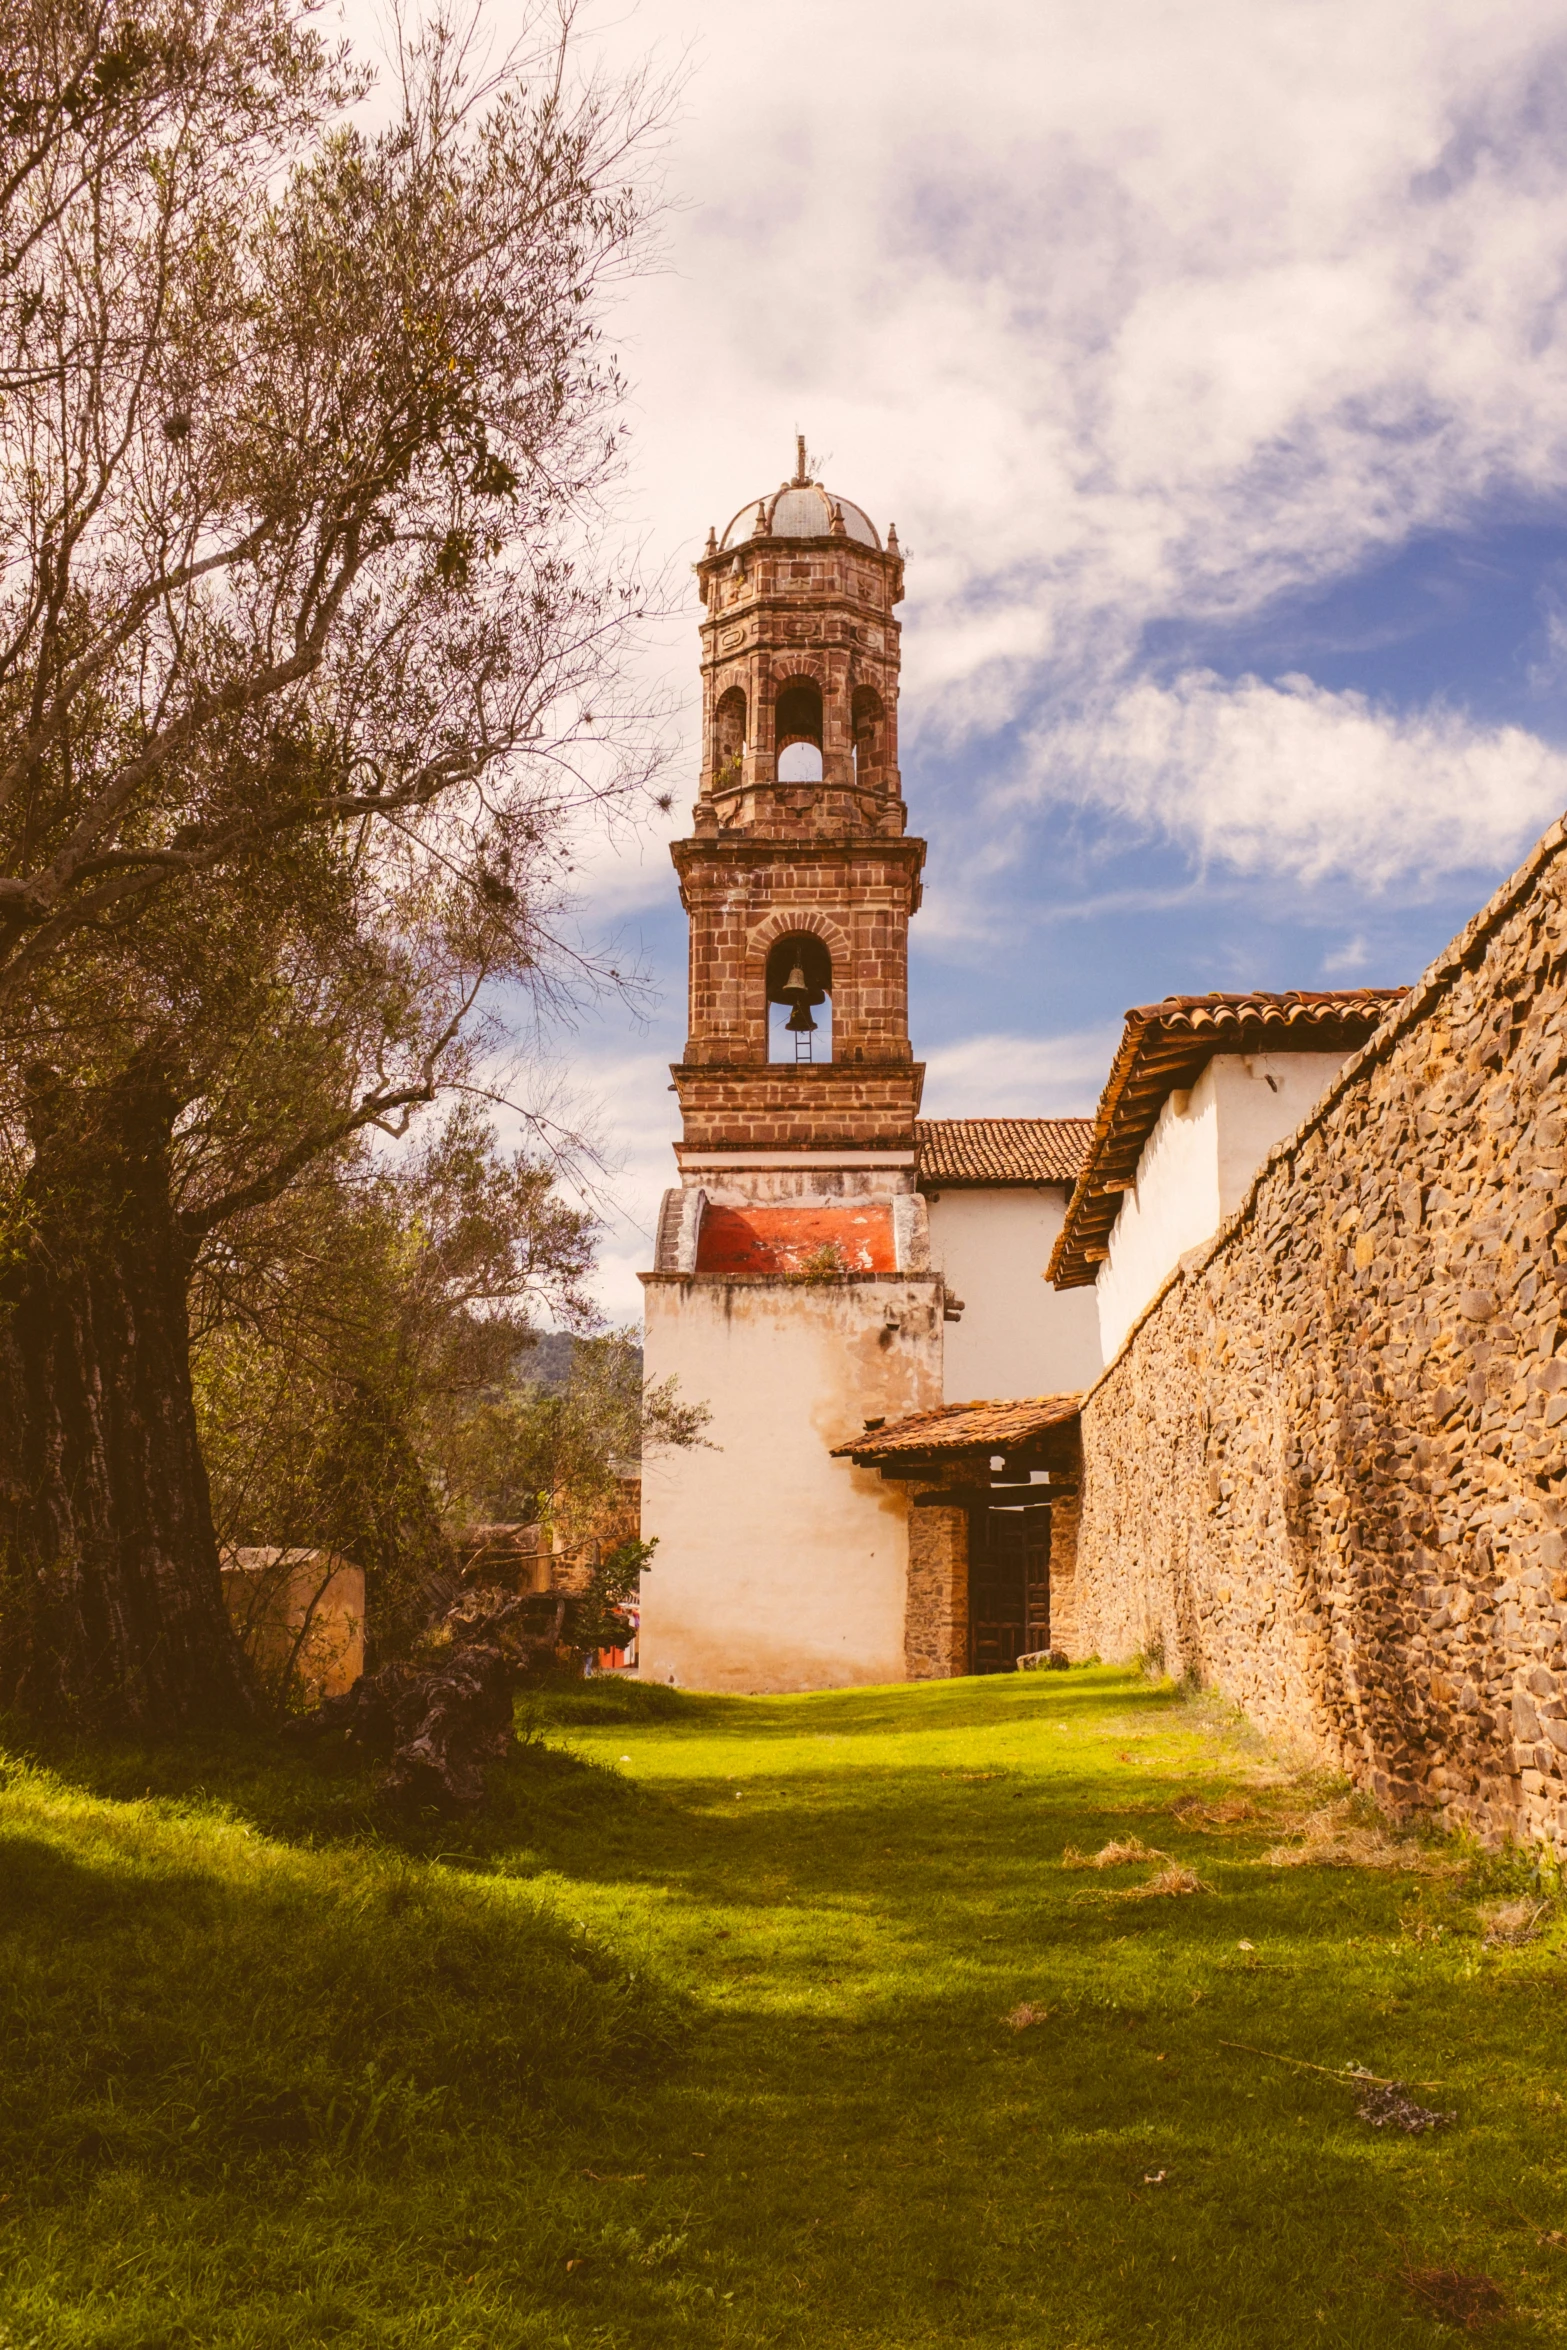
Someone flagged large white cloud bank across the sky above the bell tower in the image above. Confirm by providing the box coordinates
[582,0,1567,733]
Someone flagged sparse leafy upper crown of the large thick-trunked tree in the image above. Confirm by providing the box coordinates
[0,0,667,1041]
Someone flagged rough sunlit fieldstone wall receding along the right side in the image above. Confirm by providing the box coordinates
[1071,825,1567,1845]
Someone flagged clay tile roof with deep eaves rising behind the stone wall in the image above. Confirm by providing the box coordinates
[1045,987,1407,1290]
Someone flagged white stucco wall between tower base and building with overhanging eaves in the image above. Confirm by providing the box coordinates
[926,1184,1099,1403]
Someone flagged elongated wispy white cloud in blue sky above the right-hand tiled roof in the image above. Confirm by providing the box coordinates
[1029,670,1567,891]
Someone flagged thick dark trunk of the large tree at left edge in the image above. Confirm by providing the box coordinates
[0,1067,256,1734]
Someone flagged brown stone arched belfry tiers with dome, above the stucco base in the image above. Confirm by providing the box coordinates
[674,439,926,1166]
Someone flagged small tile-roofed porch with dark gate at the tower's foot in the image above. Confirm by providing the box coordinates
[834,1396,1081,1680]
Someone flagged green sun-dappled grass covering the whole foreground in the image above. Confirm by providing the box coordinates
[0,1669,1567,2350]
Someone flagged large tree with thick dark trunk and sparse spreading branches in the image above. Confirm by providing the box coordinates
[0,0,658,1730]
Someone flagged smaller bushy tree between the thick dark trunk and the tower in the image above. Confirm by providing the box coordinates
[193,1107,594,1661]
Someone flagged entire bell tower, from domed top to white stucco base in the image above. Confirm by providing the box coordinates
[641,442,944,1690]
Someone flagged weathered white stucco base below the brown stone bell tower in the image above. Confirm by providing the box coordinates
[639,1274,942,1690]
